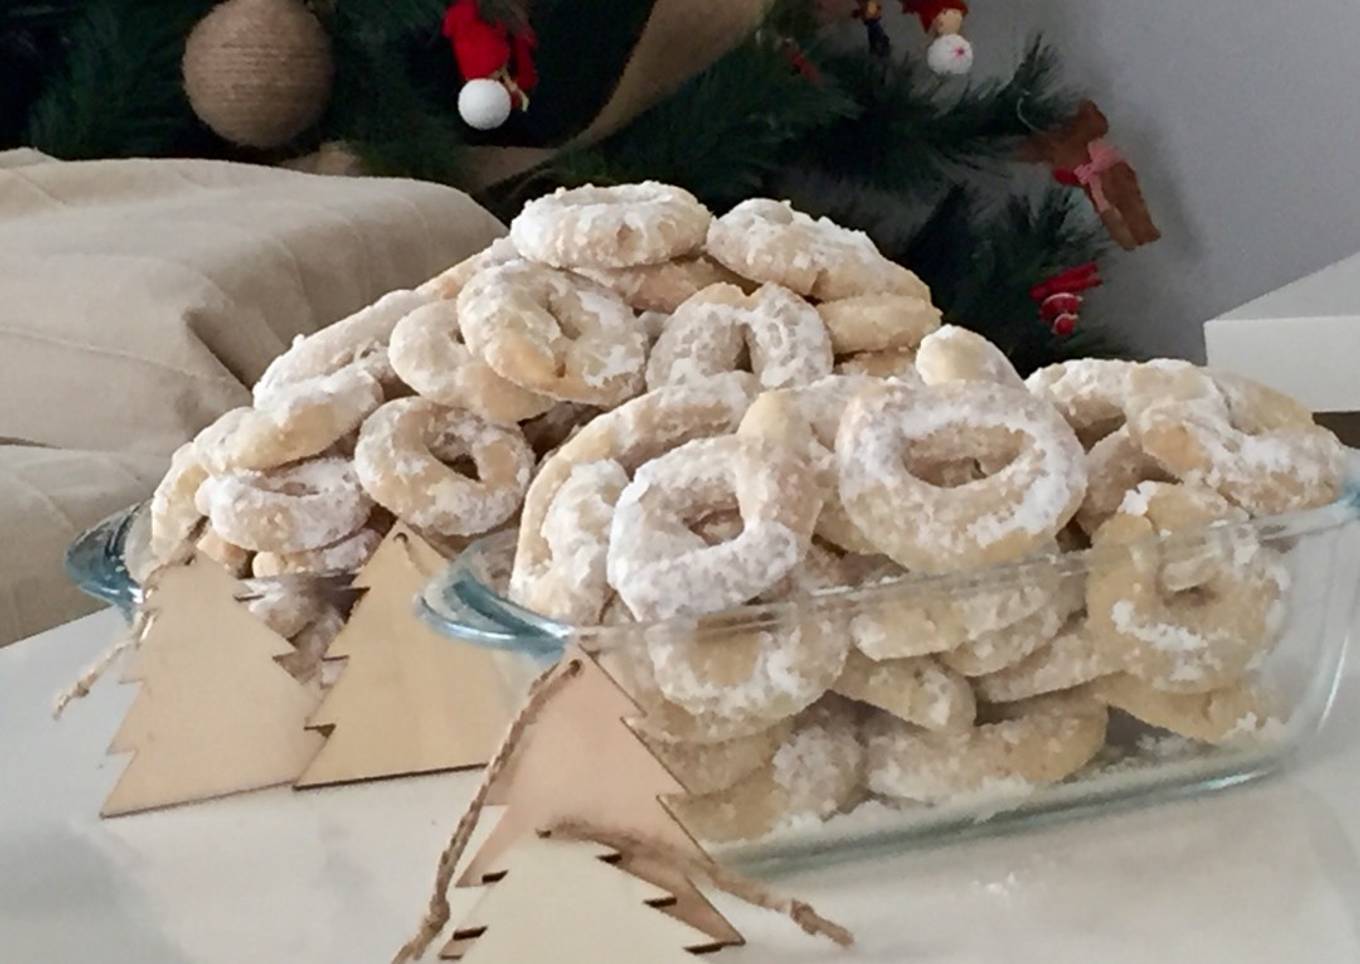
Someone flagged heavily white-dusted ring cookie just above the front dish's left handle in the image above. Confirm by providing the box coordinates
[608,435,821,621]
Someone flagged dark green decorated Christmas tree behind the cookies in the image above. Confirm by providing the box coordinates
[13,0,1158,373]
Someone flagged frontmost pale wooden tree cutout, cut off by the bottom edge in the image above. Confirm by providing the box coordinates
[446,835,711,964]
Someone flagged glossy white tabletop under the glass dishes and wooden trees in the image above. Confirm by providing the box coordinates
[0,612,1360,964]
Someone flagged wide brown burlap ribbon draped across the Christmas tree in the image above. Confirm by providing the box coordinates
[462,0,771,192]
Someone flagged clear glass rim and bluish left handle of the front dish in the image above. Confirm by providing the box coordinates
[419,487,1360,659]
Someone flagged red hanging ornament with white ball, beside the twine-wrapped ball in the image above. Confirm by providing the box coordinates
[443,0,539,131]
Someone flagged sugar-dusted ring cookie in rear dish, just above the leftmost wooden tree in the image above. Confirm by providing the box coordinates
[199,458,373,552]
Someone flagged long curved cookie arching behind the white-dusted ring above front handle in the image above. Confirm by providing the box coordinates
[510,374,755,609]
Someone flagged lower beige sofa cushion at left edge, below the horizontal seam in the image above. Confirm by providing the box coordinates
[0,445,166,646]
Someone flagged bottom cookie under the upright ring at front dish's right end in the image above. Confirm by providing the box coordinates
[1091,673,1277,744]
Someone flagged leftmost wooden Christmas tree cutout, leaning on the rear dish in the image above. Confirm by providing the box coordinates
[101,557,321,817]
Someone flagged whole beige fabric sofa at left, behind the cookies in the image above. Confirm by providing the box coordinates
[0,151,503,644]
